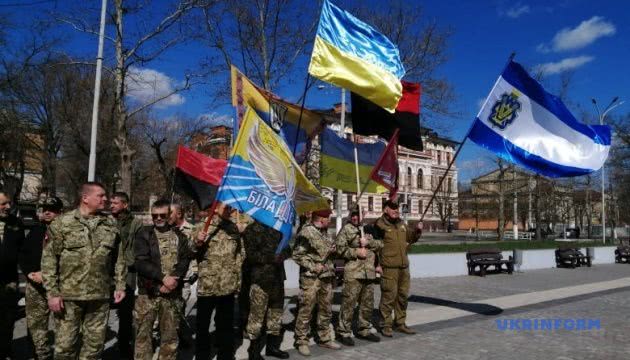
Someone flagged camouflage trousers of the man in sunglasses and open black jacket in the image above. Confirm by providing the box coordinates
[134,295,182,360]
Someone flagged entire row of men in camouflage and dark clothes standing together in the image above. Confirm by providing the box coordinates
[0,182,419,360]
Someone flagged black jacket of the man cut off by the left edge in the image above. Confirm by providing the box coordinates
[0,215,24,285]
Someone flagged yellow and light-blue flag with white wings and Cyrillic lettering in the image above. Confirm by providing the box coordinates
[216,109,330,252]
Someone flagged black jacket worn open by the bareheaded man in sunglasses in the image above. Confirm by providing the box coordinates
[133,226,192,296]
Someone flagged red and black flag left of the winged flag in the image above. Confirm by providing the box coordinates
[175,146,227,209]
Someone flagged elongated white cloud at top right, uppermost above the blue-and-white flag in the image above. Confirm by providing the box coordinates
[537,16,617,52]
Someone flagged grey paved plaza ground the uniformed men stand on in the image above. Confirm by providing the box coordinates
[9,264,630,360]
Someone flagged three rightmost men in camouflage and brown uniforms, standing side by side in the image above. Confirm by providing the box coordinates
[292,201,421,356]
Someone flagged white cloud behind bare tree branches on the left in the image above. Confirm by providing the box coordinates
[127,67,186,109]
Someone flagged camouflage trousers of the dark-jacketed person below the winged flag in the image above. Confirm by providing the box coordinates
[246,284,284,340]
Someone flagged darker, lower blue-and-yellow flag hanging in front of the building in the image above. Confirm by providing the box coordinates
[319,128,388,193]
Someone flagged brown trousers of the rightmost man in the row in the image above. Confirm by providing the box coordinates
[379,267,410,328]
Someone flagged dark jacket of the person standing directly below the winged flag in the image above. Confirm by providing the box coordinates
[243,222,290,287]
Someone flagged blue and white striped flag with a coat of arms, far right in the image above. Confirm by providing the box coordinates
[468,61,611,178]
